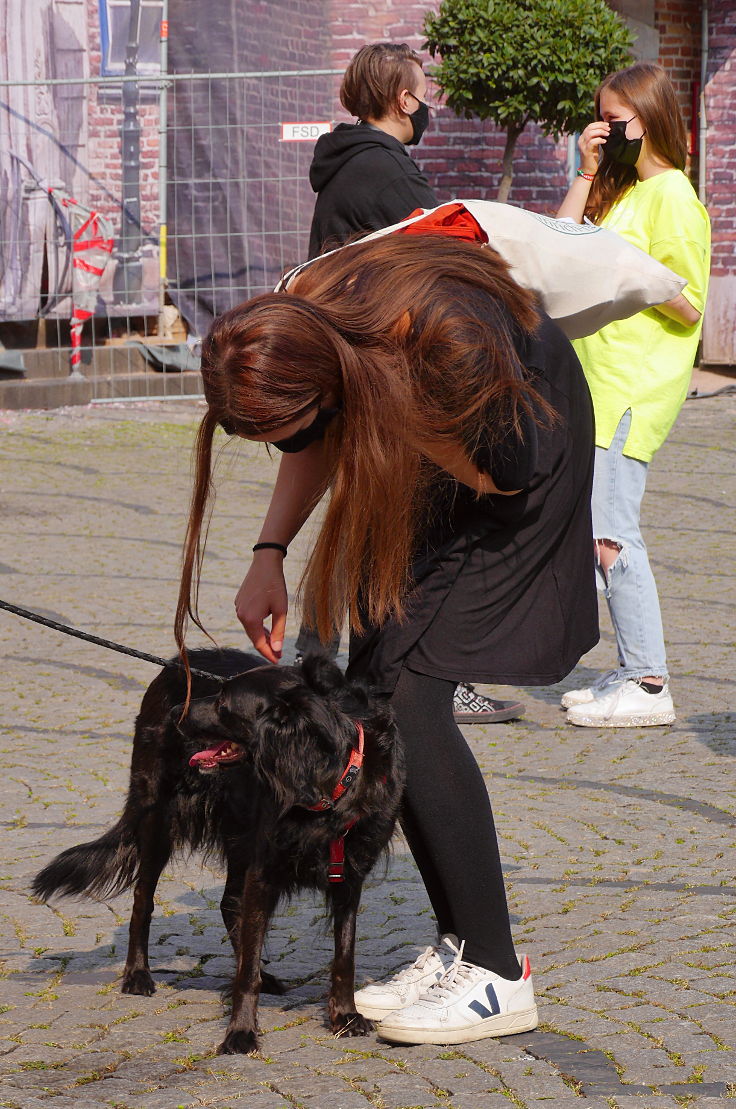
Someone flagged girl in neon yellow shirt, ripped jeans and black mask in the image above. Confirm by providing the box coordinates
[558,62,711,728]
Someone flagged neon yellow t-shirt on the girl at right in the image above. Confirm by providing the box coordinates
[573,170,711,462]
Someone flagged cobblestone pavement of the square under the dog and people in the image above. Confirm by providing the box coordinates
[0,396,736,1109]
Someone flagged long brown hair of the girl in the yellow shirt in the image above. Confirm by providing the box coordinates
[585,62,687,223]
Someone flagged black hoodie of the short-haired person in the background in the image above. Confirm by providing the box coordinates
[309,123,438,258]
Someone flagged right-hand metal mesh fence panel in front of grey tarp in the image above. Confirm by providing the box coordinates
[167,72,334,334]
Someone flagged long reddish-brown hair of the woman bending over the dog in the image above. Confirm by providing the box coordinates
[175,235,544,649]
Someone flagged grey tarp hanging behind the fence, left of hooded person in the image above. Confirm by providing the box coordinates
[167,0,336,335]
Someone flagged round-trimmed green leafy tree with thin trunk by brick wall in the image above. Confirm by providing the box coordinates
[425,0,633,201]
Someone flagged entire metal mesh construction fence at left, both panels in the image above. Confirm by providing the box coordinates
[0,70,340,407]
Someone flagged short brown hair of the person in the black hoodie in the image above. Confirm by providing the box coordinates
[340,42,421,120]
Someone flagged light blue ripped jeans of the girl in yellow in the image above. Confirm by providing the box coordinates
[592,409,667,681]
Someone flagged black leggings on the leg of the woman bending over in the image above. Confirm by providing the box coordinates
[391,667,521,979]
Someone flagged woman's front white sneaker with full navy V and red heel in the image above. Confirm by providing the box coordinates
[376,945,538,1044]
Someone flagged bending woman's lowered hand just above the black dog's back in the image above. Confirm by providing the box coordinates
[235,550,288,662]
